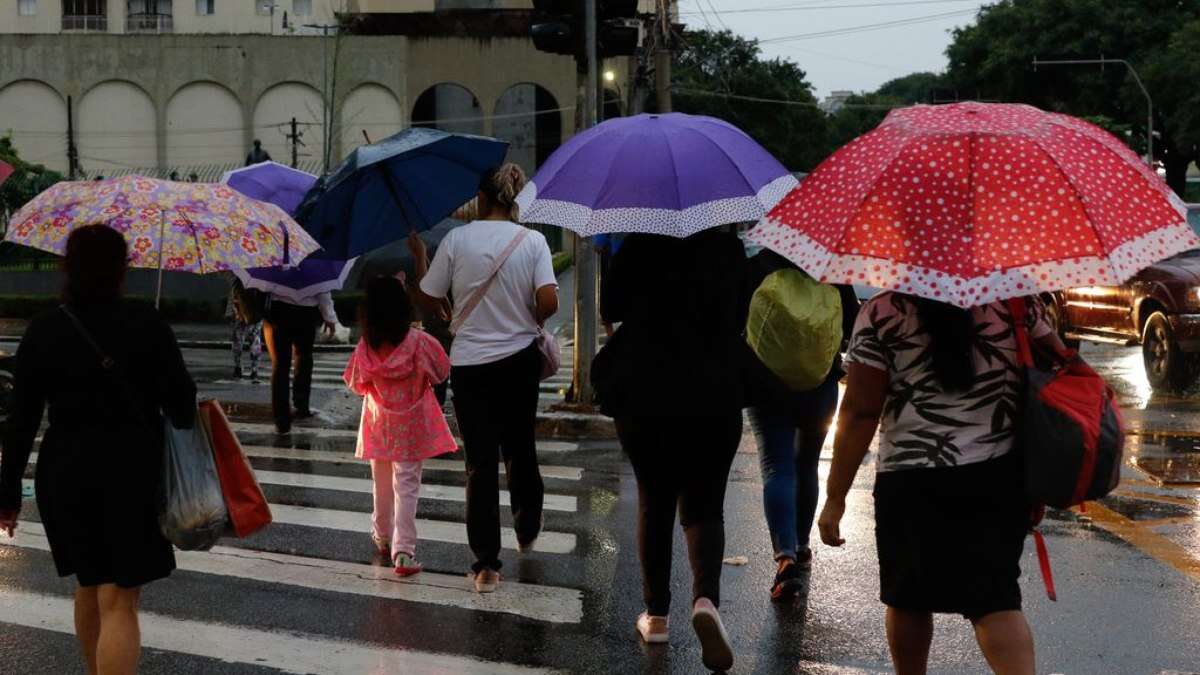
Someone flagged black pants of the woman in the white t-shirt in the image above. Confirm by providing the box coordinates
[450,345,545,572]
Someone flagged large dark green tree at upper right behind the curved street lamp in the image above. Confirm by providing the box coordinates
[947,0,1200,195]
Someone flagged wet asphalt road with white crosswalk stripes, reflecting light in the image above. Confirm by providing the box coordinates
[0,338,1200,674]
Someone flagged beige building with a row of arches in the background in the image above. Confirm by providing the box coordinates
[0,0,653,180]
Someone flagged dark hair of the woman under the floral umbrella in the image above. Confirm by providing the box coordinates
[62,225,130,305]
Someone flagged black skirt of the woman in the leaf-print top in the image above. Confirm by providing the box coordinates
[875,454,1030,621]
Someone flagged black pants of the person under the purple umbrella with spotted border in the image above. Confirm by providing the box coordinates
[616,411,742,616]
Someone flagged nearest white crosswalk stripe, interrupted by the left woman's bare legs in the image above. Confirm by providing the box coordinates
[0,590,554,675]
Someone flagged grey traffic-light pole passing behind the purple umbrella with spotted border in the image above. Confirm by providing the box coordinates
[571,0,600,407]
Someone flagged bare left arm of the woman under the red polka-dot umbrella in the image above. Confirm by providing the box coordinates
[817,363,888,546]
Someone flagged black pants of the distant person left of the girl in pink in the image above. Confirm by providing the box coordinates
[263,300,320,429]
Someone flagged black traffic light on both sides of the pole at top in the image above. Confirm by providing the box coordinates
[529,0,641,61]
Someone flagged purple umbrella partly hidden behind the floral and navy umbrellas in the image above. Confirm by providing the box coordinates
[221,162,354,301]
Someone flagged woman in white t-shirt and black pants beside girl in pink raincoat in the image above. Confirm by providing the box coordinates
[409,165,558,593]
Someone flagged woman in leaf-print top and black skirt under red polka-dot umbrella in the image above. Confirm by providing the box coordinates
[818,293,1062,675]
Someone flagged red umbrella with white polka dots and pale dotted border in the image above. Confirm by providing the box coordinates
[750,103,1200,307]
